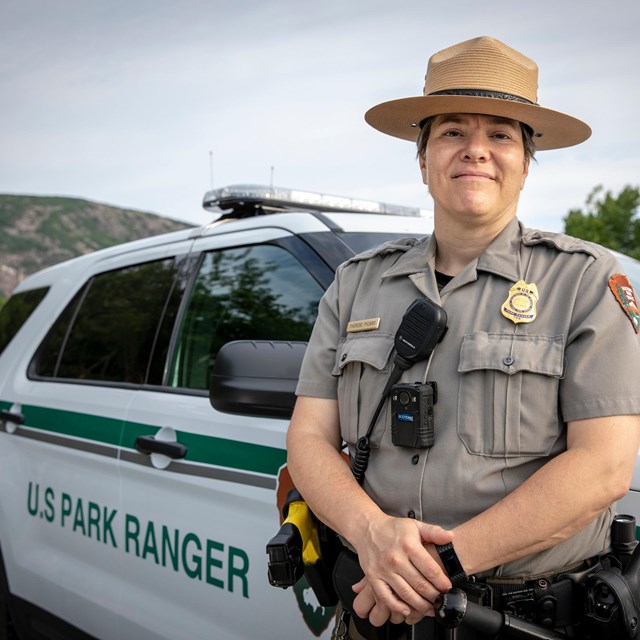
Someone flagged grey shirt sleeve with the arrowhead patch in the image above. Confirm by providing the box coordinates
[560,253,640,422]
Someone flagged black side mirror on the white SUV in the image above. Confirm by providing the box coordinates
[209,340,307,418]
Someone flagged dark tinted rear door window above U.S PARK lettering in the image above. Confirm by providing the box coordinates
[33,259,181,384]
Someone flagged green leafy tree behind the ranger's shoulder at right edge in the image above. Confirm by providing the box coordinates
[564,185,640,259]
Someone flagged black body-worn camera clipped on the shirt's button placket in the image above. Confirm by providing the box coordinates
[391,382,437,449]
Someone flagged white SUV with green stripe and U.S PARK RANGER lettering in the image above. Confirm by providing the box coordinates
[0,188,640,640]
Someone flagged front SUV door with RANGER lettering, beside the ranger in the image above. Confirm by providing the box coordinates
[121,228,333,640]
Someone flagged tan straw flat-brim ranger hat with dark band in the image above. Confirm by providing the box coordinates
[365,36,591,149]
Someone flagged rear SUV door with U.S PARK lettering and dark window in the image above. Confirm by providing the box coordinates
[0,242,195,638]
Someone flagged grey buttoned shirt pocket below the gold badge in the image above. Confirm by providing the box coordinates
[458,332,564,457]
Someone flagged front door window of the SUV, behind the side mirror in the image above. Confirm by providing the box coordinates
[169,245,324,390]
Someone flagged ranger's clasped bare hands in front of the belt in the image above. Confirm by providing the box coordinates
[353,515,453,627]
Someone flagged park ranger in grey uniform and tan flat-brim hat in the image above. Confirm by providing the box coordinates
[288,37,640,638]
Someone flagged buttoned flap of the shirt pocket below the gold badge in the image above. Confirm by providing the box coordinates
[458,331,564,378]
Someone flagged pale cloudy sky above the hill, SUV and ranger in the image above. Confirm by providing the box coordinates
[0,0,640,231]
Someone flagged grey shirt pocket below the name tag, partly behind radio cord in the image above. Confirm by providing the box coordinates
[332,332,394,447]
